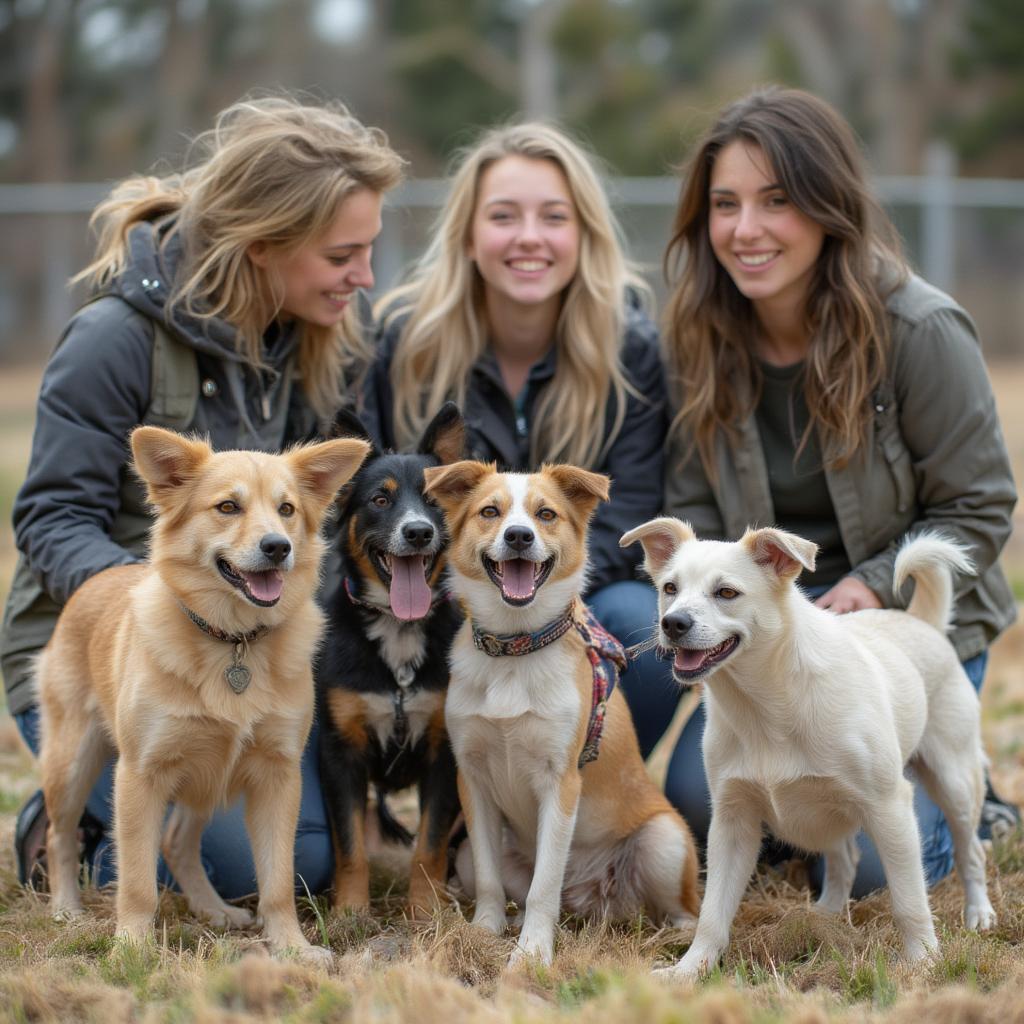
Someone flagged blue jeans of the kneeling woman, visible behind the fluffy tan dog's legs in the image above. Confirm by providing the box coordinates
[14,708,334,899]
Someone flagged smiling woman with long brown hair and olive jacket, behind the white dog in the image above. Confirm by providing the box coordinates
[647,88,1019,893]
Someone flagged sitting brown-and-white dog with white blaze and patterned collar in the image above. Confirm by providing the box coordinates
[425,462,699,963]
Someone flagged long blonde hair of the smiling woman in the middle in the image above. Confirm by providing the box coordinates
[377,124,647,466]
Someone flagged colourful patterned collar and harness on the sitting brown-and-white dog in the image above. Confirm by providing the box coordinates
[473,600,628,768]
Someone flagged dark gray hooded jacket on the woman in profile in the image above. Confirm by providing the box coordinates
[0,221,317,713]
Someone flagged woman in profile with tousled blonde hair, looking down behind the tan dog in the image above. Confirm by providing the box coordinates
[0,96,402,898]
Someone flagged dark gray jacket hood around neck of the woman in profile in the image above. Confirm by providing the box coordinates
[110,218,297,366]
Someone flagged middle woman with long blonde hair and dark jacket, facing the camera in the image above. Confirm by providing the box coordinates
[367,124,666,638]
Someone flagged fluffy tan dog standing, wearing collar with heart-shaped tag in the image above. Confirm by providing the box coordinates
[38,427,369,961]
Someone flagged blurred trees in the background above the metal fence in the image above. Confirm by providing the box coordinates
[0,0,1024,181]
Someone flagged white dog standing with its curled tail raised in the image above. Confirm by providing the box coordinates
[622,518,995,977]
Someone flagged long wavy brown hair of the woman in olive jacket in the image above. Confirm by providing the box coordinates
[664,87,907,478]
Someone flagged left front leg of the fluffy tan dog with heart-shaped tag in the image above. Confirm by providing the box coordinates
[114,755,174,942]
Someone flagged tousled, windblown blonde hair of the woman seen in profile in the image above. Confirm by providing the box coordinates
[74,96,403,419]
